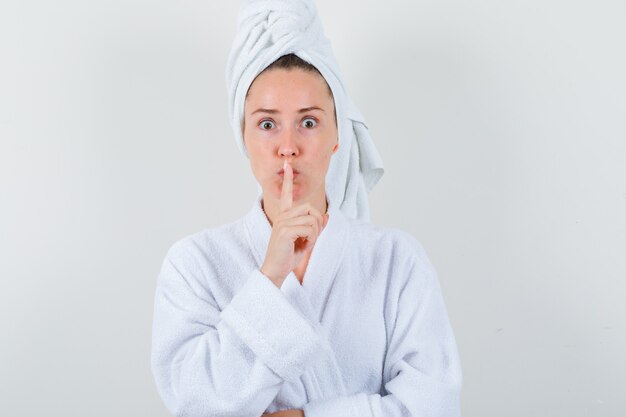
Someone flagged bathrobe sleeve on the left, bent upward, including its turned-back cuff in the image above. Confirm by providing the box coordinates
[151,240,324,417]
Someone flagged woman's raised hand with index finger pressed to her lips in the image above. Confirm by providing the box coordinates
[261,160,328,288]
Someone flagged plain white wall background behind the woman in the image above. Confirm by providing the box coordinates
[0,0,626,417]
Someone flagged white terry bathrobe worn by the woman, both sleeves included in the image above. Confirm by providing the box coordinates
[152,194,462,417]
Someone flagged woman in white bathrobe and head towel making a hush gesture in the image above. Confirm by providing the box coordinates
[152,0,461,417]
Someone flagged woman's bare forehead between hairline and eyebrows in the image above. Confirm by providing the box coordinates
[246,68,332,106]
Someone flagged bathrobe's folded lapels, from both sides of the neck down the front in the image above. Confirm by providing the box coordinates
[245,193,349,400]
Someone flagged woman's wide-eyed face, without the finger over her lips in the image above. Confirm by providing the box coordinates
[243,69,338,202]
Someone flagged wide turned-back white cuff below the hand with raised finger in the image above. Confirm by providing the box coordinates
[220,269,327,381]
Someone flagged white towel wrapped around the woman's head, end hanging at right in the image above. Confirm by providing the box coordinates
[226,0,384,221]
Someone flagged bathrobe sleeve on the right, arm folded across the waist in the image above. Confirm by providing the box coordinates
[303,241,462,417]
